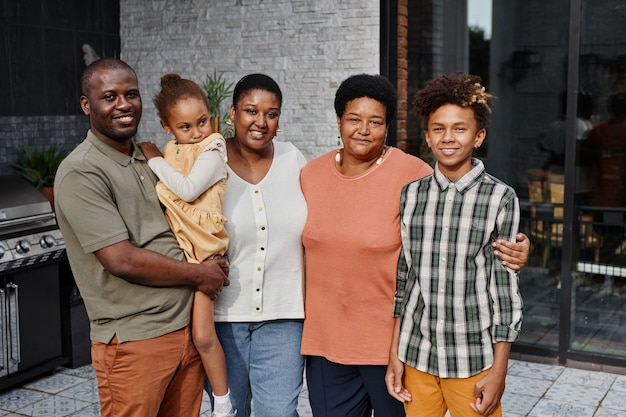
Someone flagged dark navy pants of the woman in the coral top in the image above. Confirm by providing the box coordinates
[306,356,405,417]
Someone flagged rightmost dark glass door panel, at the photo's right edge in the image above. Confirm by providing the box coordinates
[571,0,626,356]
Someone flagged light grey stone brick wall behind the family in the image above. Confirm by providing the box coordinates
[120,0,380,159]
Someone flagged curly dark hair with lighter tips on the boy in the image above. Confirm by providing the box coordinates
[413,72,496,129]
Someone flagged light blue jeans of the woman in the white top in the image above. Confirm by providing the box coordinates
[205,320,304,417]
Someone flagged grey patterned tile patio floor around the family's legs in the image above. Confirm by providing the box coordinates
[0,360,626,417]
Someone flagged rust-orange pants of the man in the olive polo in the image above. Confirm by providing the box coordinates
[91,326,204,417]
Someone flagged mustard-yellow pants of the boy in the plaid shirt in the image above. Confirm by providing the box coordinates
[404,365,502,417]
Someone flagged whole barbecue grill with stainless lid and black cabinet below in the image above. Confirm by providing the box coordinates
[0,175,67,389]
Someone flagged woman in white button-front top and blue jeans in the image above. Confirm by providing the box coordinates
[208,74,307,417]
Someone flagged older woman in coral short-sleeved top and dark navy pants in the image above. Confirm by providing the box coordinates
[298,74,529,417]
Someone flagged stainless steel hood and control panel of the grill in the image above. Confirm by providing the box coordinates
[0,175,65,274]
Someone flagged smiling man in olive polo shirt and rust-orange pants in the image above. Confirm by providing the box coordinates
[55,58,228,417]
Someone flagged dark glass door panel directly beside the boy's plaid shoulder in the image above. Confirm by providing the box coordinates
[486,0,569,350]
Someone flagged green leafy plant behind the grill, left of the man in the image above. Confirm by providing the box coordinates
[13,144,68,189]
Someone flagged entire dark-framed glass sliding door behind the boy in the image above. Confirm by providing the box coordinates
[407,0,626,366]
